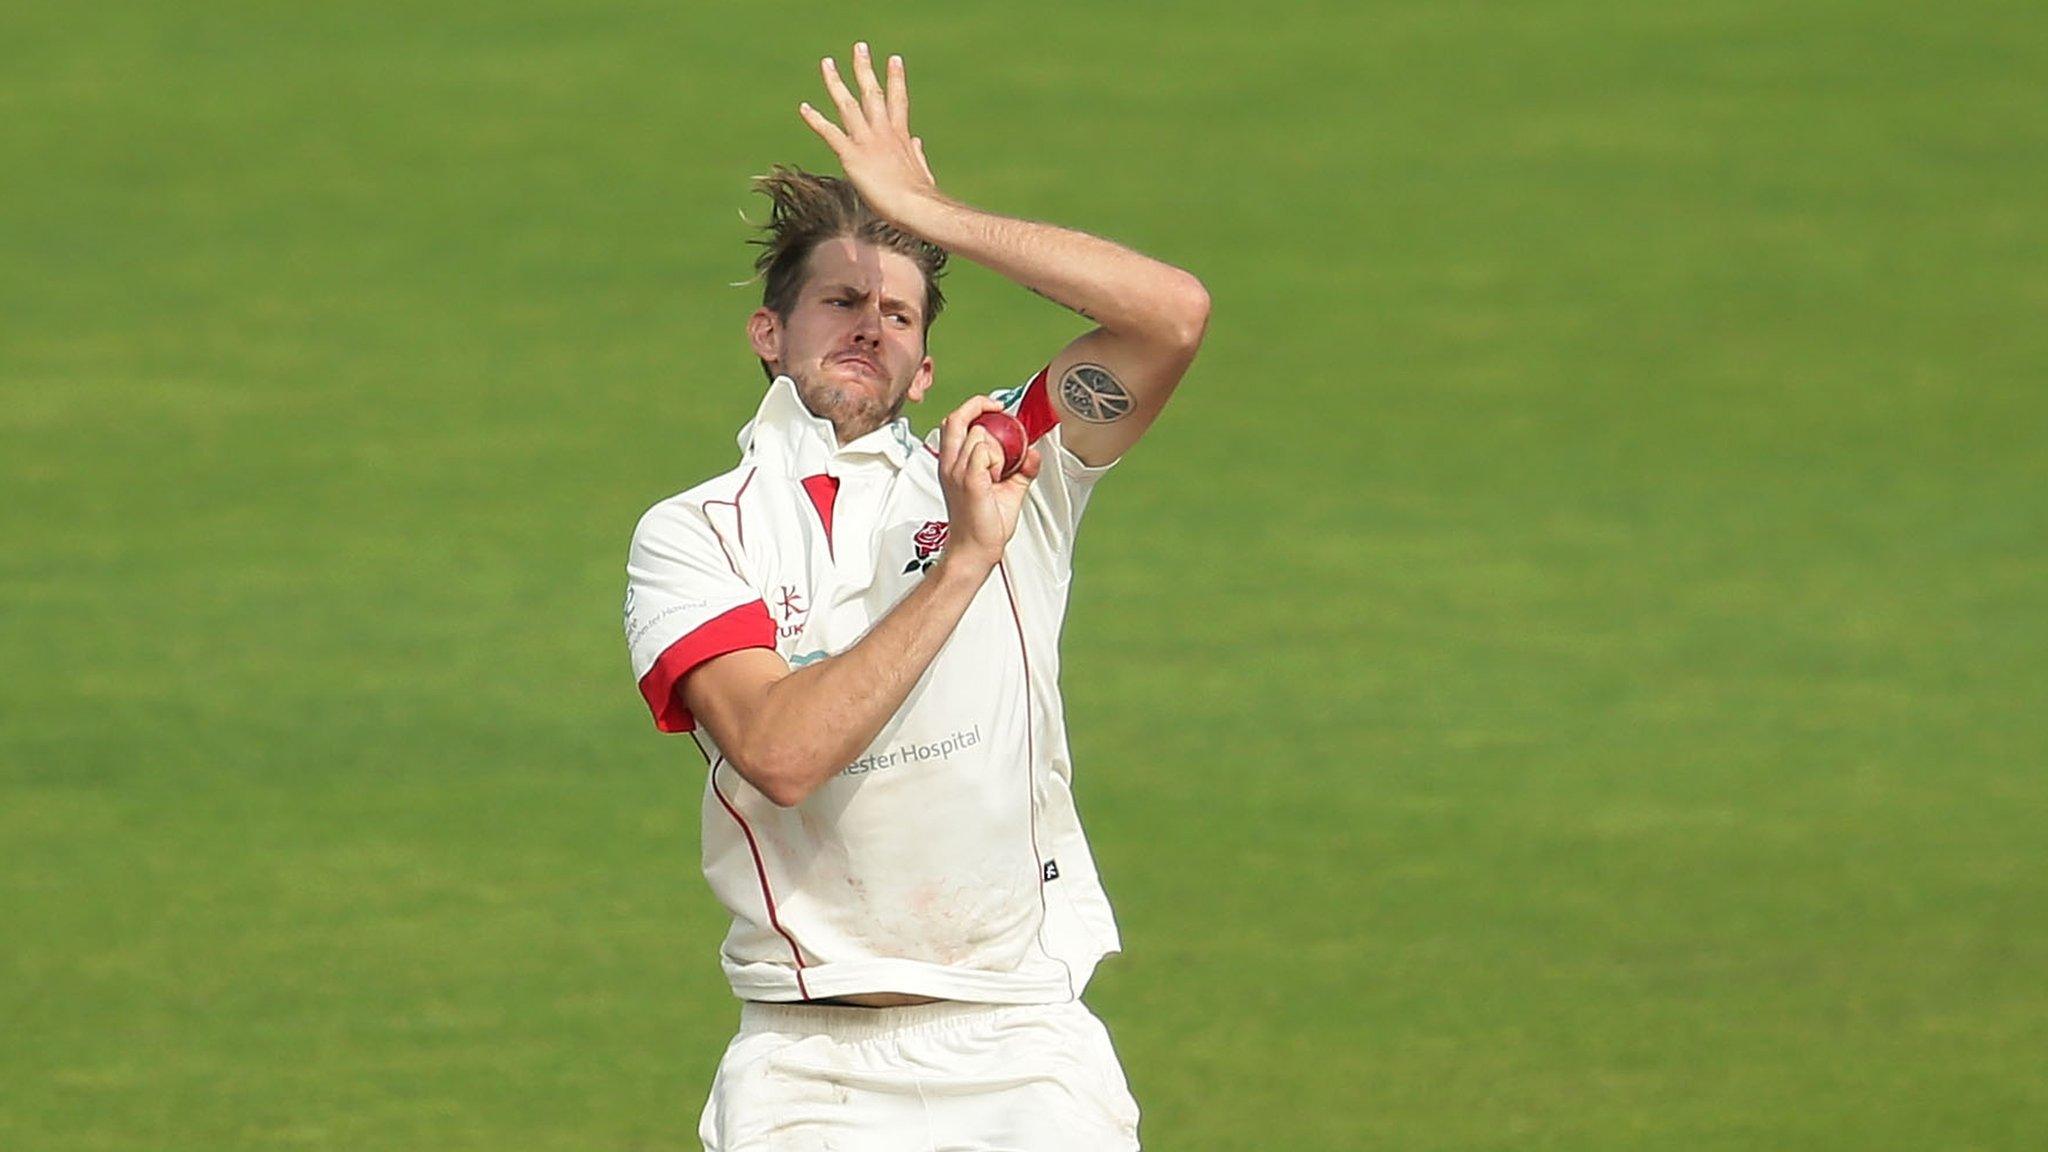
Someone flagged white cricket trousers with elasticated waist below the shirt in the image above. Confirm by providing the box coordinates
[698,1000,1139,1152]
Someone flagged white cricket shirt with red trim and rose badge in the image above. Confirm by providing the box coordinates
[625,373,1118,1002]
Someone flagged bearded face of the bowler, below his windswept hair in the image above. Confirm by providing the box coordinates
[748,238,932,445]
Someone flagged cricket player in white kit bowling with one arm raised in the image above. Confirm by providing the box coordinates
[625,45,1208,1152]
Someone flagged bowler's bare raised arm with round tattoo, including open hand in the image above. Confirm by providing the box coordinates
[799,43,1208,463]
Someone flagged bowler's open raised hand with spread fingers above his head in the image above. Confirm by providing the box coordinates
[797,43,938,223]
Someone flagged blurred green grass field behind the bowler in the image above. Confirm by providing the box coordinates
[0,0,2048,1152]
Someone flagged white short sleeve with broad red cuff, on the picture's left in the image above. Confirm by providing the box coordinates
[625,500,776,732]
